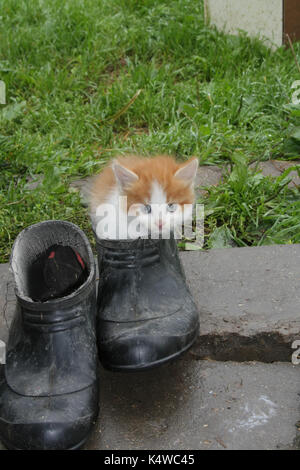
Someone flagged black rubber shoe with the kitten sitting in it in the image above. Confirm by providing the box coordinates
[97,238,199,371]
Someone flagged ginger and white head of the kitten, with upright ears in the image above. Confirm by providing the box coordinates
[112,156,198,238]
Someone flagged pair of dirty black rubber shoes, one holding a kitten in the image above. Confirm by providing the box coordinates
[0,221,199,449]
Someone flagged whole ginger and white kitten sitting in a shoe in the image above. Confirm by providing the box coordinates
[89,155,198,239]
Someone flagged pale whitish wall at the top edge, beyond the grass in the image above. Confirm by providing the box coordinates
[204,0,283,46]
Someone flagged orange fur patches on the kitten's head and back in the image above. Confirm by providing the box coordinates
[90,155,194,210]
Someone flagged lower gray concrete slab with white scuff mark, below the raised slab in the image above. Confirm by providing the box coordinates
[82,354,300,450]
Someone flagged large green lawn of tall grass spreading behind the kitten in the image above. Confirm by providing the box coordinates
[0,0,300,262]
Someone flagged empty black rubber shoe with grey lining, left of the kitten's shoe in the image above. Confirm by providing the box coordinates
[0,221,98,450]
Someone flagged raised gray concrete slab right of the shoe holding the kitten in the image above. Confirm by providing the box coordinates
[186,245,300,362]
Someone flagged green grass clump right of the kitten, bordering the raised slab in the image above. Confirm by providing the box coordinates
[202,155,300,248]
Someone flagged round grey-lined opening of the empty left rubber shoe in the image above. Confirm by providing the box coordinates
[11,221,94,302]
